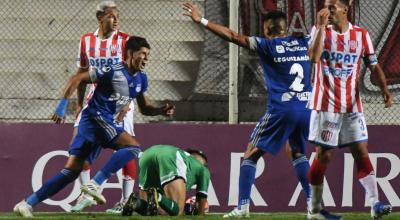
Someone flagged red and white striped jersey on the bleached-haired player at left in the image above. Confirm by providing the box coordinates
[76,29,129,102]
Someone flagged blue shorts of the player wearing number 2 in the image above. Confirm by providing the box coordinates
[250,110,311,155]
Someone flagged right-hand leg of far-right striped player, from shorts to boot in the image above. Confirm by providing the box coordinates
[341,113,392,218]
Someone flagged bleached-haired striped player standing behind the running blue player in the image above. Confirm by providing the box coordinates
[71,1,136,213]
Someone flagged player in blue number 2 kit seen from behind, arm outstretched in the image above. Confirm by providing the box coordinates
[183,3,340,217]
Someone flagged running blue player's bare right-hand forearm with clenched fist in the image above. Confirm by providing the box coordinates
[136,94,175,116]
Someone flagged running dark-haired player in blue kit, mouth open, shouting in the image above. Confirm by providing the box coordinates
[14,37,173,217]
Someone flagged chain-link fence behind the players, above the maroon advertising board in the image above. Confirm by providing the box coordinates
[0,0,400,124]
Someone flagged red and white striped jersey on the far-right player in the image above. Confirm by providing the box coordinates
[309,23,378,113]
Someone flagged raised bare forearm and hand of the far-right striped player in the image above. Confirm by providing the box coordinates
[308,8,329,63]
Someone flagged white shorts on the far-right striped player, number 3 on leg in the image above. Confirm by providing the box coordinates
[308,110,368,148]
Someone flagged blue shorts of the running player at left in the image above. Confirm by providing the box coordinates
[68,111,125,164]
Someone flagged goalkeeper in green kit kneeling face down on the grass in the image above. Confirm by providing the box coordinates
[122,145,210,216]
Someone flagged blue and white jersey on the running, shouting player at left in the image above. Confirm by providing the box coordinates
[88,64,148,118]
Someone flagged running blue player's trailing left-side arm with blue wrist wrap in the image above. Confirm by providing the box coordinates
[51,72,91,124]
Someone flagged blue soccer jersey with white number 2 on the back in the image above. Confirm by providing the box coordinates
[249,36,312,113]
